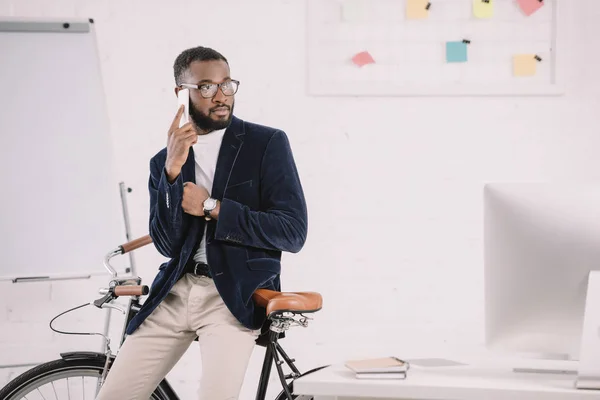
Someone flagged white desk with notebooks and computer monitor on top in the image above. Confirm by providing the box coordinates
[294,365,600,400]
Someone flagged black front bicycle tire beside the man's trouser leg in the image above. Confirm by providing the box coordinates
[0,354,177,400]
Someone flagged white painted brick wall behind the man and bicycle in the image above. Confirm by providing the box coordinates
[0,0,600,399]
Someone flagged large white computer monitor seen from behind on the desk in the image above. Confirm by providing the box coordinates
[484,183,600,360]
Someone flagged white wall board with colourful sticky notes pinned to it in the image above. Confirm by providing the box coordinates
[307,0,564,96]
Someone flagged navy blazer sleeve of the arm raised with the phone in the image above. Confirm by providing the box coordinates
[148,158,183,258]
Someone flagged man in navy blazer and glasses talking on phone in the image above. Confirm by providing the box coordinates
[97,47,307,400]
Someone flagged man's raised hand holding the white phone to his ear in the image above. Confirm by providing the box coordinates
[165,106,198,183]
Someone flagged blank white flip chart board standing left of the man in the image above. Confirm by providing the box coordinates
[0,19,127,279]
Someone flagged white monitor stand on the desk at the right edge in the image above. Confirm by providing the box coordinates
[575,271,600,390]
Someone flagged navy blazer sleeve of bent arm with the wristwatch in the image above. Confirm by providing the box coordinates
[215,131,308,253]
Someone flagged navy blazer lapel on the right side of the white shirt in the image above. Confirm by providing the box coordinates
[210,117,245,200]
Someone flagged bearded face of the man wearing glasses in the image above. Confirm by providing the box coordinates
[183,60,235,133]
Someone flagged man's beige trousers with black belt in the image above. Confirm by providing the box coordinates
[96,274,260,400]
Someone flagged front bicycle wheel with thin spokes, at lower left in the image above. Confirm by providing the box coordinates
[0,353,177,400]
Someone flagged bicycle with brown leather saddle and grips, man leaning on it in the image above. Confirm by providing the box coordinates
[0,236,327,400]
